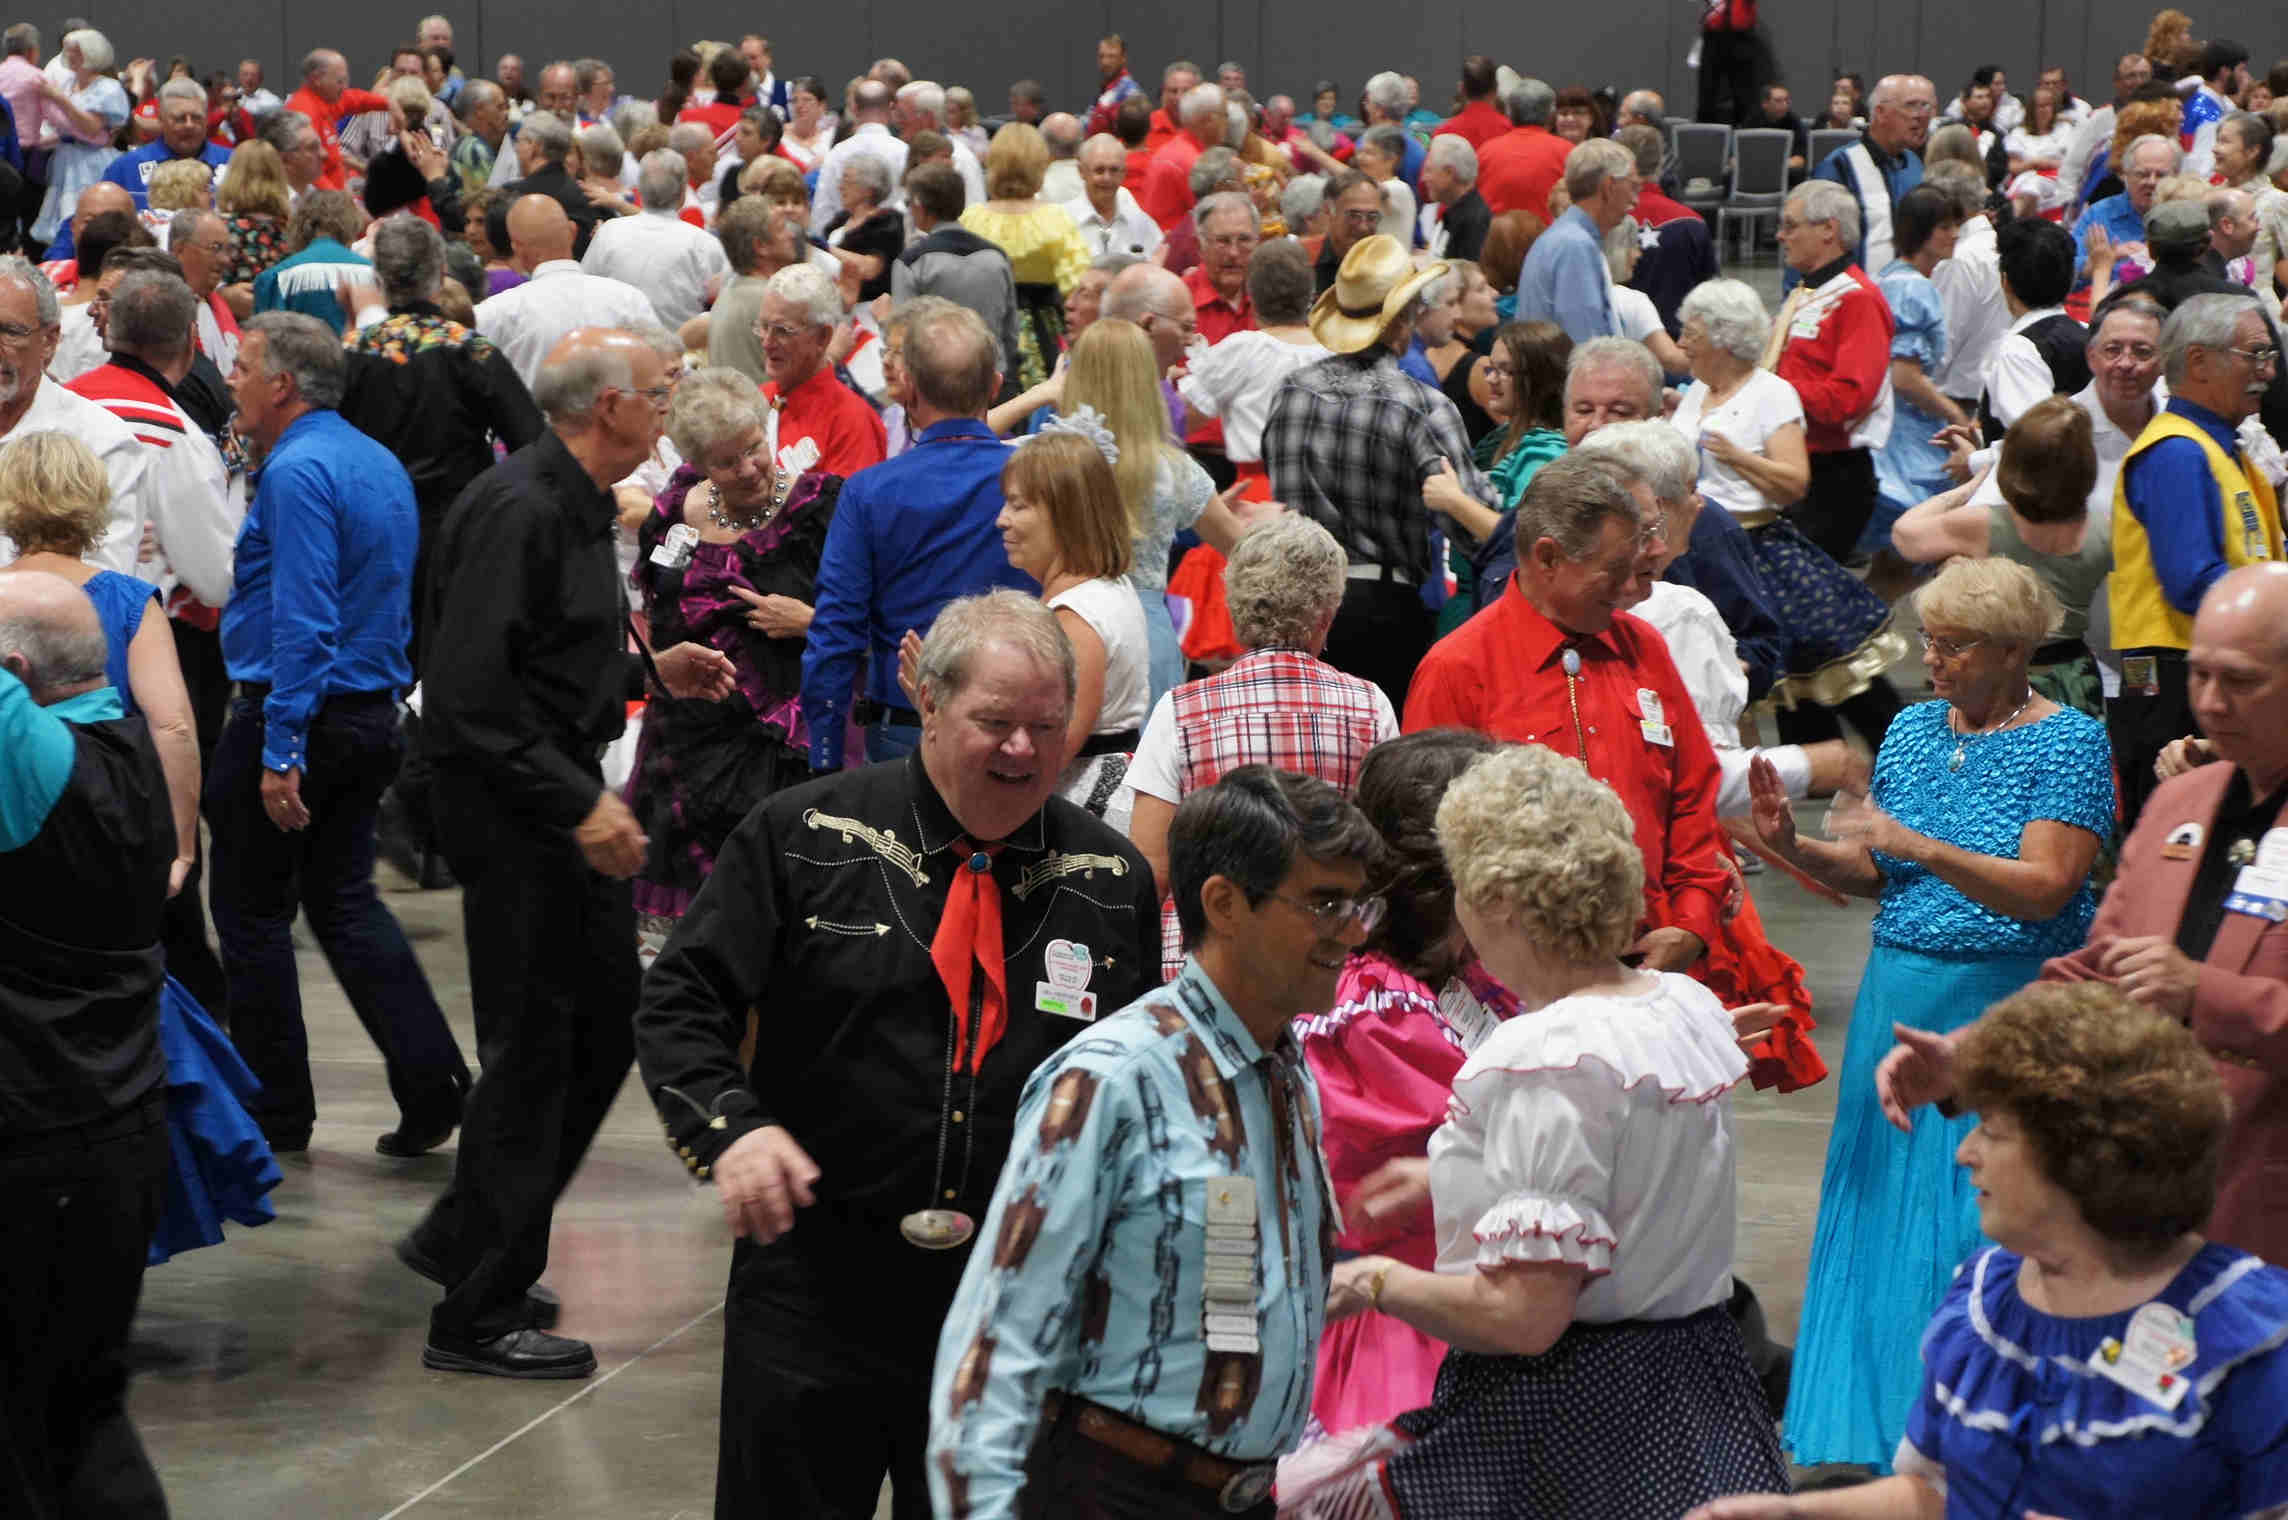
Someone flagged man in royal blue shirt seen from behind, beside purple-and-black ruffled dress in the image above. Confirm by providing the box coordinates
[803,302,1039,771]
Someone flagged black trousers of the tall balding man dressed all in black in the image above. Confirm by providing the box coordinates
[414,771,641,1339]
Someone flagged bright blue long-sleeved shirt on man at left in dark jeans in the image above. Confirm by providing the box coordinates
[222,410,421,771]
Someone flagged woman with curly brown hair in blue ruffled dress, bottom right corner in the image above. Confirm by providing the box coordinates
[1686,982,2288,1520]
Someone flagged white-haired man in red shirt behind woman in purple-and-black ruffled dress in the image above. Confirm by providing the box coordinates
[755,263,890,476]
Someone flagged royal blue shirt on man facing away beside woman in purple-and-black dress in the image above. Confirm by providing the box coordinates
[803,417,1036,771]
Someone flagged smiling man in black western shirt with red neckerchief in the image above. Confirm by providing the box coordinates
[636,591,1160,1520]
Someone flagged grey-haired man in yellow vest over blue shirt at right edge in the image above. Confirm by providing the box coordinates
[2105,295,2281,824]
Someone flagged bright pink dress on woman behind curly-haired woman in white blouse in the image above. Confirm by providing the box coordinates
[1295,950,1517,1435]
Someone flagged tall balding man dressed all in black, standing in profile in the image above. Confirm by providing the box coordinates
[398,327,732,1378]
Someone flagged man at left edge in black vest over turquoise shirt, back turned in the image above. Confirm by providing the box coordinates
[0,572,174,1518]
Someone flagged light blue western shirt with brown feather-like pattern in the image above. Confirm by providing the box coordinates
[929,959,1336,1520]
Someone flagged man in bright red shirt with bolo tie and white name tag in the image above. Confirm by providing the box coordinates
[1405,453,1730,971]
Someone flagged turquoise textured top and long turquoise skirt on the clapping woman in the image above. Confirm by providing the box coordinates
[1785,703,2114,1474]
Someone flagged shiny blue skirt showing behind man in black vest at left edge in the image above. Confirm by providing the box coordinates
[151,977,281,1266]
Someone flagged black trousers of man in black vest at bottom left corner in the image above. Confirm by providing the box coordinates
[0,1097,167,1520]
